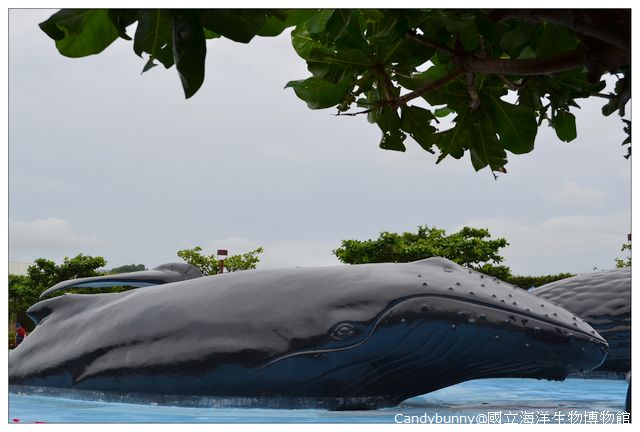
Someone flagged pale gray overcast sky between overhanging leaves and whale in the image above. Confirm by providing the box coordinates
[9,10,631,274]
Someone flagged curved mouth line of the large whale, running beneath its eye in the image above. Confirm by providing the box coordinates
[256,294,602,372]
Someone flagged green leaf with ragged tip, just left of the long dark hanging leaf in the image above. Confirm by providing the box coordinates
[133,9,174,72]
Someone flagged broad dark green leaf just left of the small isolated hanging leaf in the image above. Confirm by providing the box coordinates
[482,94,538,154]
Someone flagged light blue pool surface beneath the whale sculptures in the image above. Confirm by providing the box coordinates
[9,378,628,423]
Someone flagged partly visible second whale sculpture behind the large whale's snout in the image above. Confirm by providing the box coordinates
[531,268,631,373]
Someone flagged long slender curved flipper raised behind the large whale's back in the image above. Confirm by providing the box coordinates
[40,263,203,299]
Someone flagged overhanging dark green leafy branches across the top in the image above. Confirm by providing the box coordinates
[40,9,631,175]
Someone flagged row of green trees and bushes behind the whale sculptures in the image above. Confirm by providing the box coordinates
[8,226,631,330]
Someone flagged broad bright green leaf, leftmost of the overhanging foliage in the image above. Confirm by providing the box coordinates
[40,9,119,57]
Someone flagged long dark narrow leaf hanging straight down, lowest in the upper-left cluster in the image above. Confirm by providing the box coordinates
[172,10,207,99]
